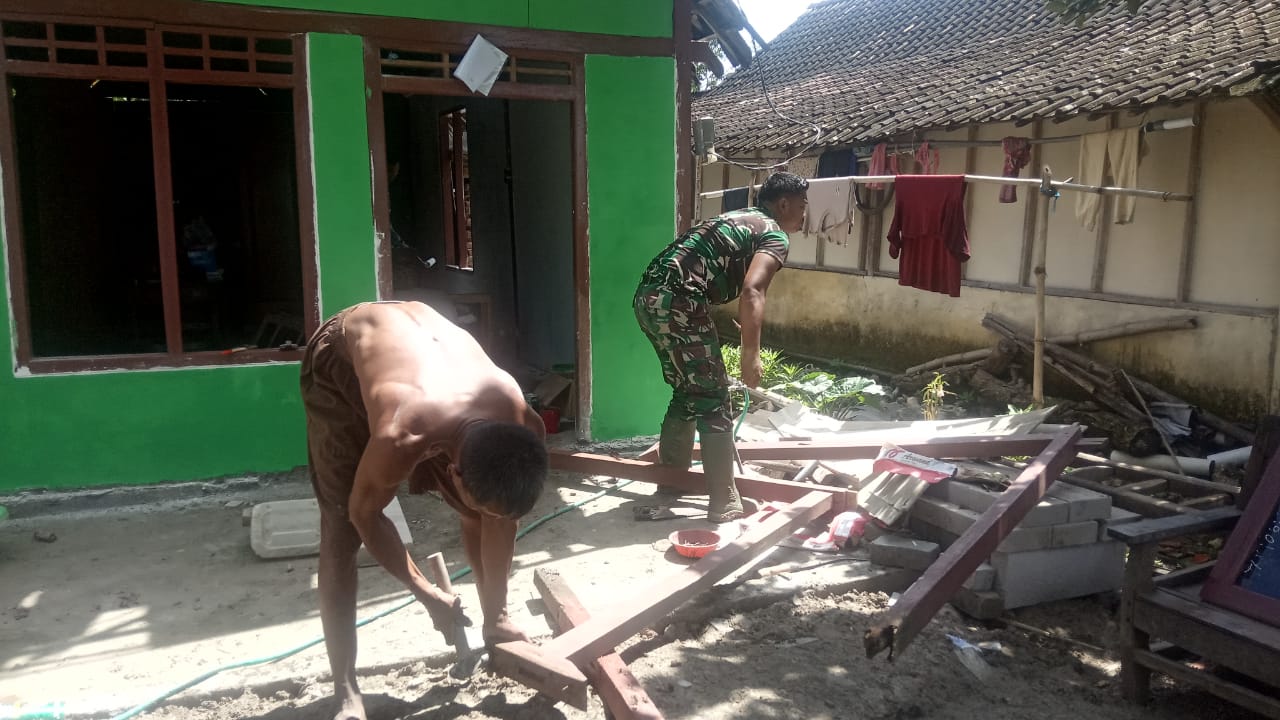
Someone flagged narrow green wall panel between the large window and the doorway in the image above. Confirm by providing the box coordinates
[307,33,378,318]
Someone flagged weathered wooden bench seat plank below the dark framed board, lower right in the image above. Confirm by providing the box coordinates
[1134,591,1280,687]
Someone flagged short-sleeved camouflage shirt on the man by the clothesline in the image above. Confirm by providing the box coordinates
[640,208,790,305]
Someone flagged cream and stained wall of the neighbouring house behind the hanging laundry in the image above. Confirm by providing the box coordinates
[704,99,1280,419]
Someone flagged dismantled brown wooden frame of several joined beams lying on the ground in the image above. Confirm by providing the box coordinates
[509,425,1082,708]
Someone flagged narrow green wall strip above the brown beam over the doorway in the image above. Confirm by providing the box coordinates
[209,0,672,37]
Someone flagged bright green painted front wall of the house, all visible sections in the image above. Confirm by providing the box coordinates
[0,0,676,492]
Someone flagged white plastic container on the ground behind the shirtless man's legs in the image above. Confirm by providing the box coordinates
[248,498,413,566]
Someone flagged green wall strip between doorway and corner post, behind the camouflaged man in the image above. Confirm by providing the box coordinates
[586,55,676,439]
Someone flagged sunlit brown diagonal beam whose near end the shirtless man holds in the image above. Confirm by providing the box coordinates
[493,488,832,710]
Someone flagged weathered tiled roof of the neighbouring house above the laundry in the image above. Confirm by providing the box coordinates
[692,0,1280,152]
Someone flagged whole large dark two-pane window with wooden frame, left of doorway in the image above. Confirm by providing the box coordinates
[0,19,316,369]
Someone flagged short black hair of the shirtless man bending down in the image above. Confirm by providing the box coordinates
[458,423,547,518]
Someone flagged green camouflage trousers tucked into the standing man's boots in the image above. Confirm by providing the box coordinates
[634,284,733,433]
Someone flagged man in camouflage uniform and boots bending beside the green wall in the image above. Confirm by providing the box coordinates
[634,173,809,523]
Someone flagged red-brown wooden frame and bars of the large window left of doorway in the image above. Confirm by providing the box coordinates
[0,16,320,374]
